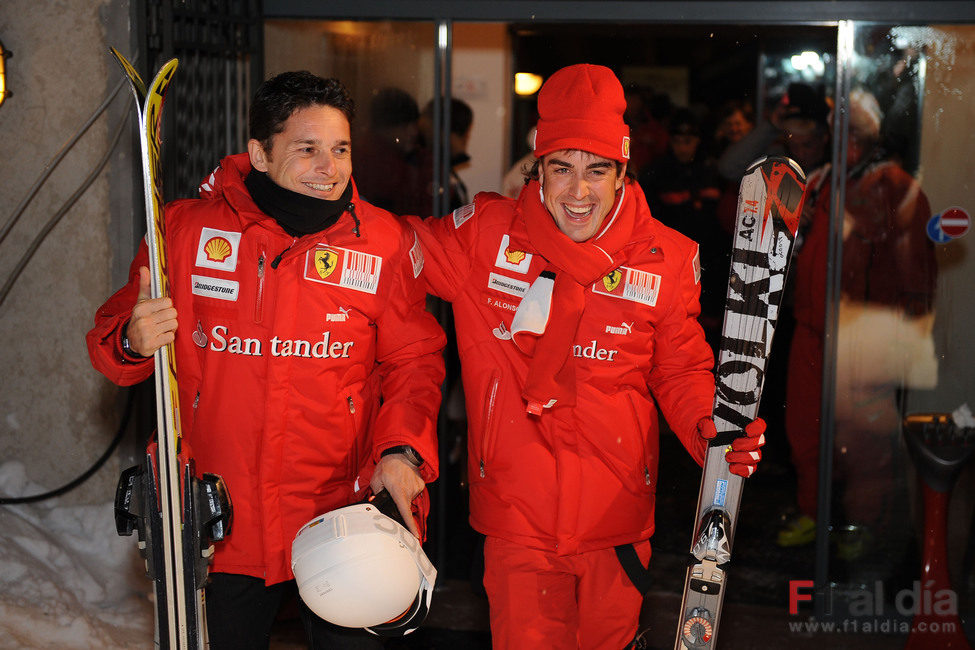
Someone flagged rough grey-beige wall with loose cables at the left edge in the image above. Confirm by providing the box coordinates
[0,0,135,503]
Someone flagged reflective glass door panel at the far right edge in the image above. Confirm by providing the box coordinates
[816,23,975,636]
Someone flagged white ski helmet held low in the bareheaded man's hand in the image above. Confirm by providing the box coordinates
[291,500,437,636]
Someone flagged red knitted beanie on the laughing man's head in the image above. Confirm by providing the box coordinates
[534,63,630,162]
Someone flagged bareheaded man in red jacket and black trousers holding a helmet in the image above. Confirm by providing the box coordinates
[88,72,445,650]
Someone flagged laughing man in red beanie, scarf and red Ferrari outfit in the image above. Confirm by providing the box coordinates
[410,65,764,649]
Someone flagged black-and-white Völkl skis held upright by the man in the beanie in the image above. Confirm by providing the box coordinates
[630,157,806,650]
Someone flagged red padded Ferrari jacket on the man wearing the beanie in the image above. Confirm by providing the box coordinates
[409,182,714,555]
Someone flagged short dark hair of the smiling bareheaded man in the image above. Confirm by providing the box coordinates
[249,70,355,153]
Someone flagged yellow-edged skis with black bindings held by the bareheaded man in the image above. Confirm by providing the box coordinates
[111,48,232,650]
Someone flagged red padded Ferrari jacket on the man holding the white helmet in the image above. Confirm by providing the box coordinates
[87,154,445,584]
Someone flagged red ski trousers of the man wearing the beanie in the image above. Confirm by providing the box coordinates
[484,537,650,650]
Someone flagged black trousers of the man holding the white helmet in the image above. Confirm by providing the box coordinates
[206,573,383,650]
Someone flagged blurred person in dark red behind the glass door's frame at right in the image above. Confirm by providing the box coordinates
[777,88,937,559]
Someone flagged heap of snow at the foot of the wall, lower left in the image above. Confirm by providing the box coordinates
[0,462,153,650]
